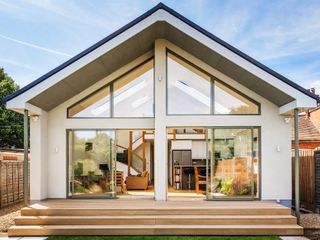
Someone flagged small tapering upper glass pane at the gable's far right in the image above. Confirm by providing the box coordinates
[214,81,259,115]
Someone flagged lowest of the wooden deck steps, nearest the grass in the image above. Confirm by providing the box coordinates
[9,225,303,236]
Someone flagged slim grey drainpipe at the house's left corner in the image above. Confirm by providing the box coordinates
[23,109,29,207]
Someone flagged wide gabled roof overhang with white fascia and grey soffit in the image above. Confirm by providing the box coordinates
[6,4,319,114]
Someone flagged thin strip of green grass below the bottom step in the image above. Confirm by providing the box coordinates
[48,236,280,240]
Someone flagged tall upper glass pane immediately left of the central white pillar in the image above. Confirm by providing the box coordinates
[113,60,154,117]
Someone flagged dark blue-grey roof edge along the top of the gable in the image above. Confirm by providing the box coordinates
[4,3,319,110]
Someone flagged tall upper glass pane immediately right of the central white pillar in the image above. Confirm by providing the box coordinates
[167,53,211,114]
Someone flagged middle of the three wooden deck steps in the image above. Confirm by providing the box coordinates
[15,215,296,225]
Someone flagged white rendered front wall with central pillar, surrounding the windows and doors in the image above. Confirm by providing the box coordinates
[43,40,291,200]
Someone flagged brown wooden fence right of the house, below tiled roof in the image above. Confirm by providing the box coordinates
[292,150,320,212]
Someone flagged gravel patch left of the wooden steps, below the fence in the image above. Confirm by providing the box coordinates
[0,203,23,232]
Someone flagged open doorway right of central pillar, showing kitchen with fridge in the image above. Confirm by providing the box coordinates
[167,127,207,199]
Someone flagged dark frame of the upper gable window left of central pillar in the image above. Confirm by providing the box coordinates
[66,56,155,119]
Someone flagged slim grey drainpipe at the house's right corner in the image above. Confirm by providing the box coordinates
[294,108,300,224]
